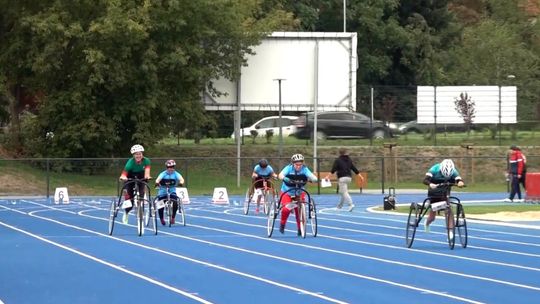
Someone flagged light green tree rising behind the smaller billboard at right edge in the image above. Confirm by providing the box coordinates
[445,0,540,120]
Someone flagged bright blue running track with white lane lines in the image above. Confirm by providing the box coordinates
[0,193,540,304]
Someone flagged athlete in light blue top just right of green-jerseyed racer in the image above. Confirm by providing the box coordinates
[156,159,184,225]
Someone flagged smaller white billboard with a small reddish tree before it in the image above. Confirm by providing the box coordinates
[416,86,517,124]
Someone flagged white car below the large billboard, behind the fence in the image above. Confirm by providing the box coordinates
[231,115,298,138]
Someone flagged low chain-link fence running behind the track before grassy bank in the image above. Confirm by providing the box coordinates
[0,154,540,196]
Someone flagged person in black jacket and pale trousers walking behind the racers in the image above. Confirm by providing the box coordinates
[325,148,364,212]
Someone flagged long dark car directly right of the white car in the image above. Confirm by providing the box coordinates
[294,112,392,139]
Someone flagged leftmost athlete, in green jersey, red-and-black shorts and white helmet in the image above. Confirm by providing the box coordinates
[120,145,150,224]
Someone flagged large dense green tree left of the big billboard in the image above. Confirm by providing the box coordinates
[0,0,294,157]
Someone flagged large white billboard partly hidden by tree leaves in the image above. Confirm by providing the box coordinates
[203,32,357,111]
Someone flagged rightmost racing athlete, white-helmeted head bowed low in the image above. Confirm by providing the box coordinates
[424,159,465,232]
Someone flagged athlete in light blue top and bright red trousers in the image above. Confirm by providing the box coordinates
[278,154,317,235]
